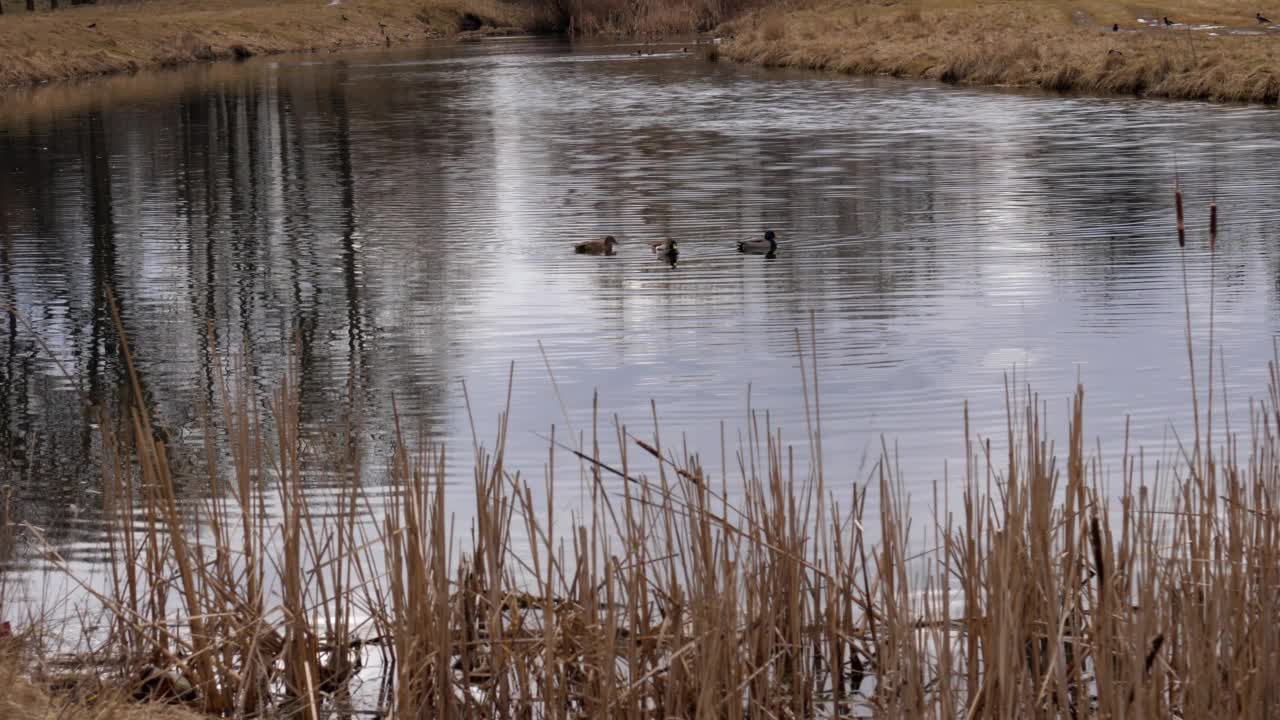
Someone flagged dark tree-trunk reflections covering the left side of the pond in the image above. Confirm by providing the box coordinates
[0,68,476,548]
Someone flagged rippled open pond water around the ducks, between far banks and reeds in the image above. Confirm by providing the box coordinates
[0,41,1280,566]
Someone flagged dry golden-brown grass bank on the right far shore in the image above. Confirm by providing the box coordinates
[719,0,1280,104]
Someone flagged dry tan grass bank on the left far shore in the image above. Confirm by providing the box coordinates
[0,0,534,86]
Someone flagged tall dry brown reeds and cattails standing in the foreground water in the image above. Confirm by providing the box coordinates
[2,193,1280,719]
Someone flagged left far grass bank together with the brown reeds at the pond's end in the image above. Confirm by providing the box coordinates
[0,0,754,87]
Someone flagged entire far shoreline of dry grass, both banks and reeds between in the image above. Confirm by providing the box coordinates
[0,0,1280,104]
